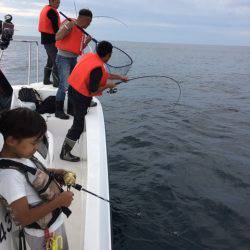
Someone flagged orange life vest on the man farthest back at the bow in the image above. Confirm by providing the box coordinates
[38,5,61,34]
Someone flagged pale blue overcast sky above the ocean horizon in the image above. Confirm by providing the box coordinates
[0,0,250,45]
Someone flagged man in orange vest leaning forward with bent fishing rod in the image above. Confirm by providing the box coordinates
[60,41,128,162]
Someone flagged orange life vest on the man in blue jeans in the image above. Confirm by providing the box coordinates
[56,18,85,55]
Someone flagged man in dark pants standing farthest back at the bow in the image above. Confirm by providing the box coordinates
[38,0,61,87]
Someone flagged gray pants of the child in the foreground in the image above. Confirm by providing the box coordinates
[25,224,69,250]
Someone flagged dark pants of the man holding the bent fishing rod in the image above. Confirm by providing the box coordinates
[66,86,92,141]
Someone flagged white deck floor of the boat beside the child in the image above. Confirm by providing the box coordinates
[47,115,87,250]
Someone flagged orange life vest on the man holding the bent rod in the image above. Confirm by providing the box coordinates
[68,53,109,97]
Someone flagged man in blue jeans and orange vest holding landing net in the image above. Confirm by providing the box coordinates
[55,9,92,119]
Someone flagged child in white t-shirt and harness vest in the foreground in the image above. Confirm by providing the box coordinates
[0,108,73,250]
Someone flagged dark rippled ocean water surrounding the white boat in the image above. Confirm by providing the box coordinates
[0,37,250,250]
